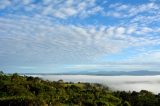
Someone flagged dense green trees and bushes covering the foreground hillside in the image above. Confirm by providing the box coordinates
[0,72,160,106]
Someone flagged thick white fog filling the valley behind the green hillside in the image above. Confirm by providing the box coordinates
[34,75,160,94]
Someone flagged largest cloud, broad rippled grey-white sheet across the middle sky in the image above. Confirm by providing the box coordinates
[0,15,160,64]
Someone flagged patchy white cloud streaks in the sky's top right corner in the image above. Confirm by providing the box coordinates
[103,1,160,26]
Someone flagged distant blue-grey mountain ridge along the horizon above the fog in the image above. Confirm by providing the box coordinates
[20,70,160,76]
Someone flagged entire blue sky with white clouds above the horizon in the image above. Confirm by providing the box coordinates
[0,0,160,73]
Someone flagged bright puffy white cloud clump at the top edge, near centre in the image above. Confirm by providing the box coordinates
[43,0,102,19]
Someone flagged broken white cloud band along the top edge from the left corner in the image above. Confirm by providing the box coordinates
[0,0,102,19]
